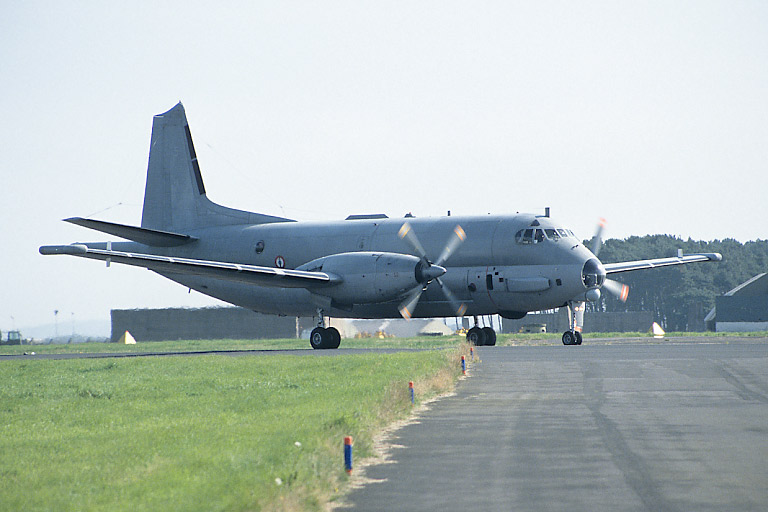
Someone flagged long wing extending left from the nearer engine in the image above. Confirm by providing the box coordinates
[40,244,341,288]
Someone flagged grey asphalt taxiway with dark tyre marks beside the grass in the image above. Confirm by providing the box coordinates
[345,339,768,512]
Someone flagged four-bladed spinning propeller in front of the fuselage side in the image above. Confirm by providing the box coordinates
[397,222,467,320]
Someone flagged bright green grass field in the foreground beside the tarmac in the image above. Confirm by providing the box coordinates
[0,344,460,510]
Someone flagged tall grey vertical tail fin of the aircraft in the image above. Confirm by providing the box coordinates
[141,102,290,232]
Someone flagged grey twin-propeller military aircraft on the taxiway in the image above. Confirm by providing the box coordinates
[40,103,722,349]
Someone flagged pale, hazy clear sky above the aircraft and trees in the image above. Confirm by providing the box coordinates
[0,0,768,332]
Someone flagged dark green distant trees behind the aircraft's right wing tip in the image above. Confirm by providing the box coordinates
[585,235,768,331]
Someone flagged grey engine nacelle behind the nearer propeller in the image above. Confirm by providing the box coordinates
[297,252,421,304]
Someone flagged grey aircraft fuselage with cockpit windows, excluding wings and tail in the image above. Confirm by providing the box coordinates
[103,214,594,318]
